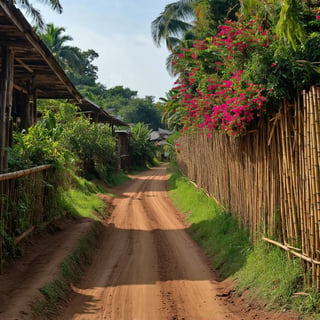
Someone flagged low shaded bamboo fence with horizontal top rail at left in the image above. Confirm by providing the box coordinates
[0,165,51,273]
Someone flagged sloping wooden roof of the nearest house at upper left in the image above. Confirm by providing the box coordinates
[0,1,81,100]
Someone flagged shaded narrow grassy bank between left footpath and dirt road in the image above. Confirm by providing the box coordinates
[31,221,102,320]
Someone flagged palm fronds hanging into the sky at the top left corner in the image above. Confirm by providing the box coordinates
[2,0,62,28]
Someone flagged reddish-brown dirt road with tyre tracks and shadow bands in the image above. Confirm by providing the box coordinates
[0,165,297,320]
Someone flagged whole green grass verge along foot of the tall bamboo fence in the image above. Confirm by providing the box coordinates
[168,165,320,320]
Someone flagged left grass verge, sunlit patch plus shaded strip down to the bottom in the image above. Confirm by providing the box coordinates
[32,174,109,319]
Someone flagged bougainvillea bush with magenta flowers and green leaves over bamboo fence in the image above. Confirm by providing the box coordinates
[173,12,320,137]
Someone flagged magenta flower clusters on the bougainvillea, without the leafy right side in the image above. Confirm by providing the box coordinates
[173,20,275,137]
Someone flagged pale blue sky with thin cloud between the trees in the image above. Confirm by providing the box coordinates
[34,0,174,100]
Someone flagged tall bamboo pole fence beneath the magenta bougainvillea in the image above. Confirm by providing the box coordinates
[177,87,320,290]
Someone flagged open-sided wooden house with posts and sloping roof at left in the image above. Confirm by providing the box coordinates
[0,1,125,174]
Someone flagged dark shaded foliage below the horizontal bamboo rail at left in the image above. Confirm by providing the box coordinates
[0,167,66,260]
